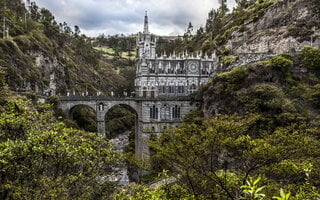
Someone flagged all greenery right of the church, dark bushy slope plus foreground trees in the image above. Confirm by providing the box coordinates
[151,54,320,199]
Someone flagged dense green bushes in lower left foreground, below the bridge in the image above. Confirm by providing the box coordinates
[0,100,121,199]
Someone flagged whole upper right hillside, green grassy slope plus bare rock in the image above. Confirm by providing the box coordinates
[178,0,320,55]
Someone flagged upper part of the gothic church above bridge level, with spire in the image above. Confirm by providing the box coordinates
[135,12,218,98]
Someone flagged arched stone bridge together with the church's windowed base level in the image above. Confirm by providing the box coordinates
[59,96,197,159]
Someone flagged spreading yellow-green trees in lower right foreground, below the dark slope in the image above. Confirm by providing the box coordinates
[151,114,320,199]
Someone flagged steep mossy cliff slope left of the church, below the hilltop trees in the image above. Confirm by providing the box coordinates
[0,34,124,95]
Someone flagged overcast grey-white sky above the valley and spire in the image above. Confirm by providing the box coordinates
[32,0,235,36]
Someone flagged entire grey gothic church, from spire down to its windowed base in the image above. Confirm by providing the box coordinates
[135,14,218,157]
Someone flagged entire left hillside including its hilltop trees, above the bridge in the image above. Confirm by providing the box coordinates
[0,0,132,95]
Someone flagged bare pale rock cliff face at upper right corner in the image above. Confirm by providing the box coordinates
[225,0,320,54]
